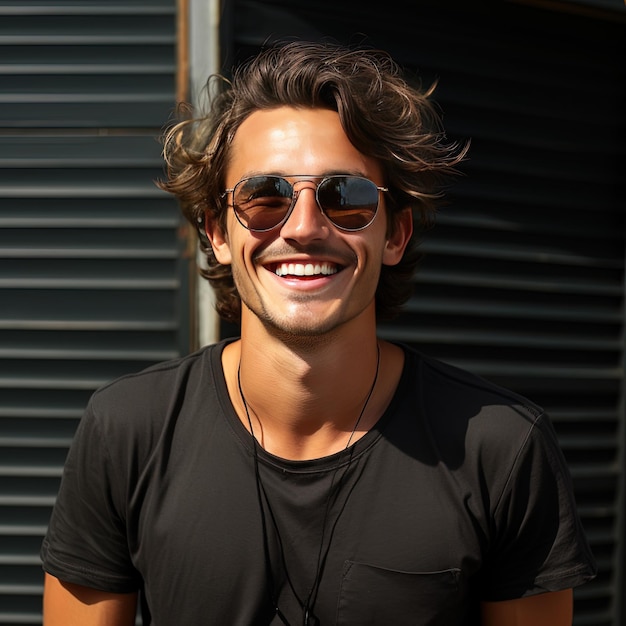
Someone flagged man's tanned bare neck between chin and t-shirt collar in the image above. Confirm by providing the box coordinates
[224,324,382,459]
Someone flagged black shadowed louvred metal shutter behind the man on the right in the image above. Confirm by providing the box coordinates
[224,0,626,626]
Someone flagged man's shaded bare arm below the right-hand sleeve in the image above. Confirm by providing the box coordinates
[481,589,573,626]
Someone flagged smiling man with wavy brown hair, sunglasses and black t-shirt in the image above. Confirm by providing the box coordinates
[42,43,595,626]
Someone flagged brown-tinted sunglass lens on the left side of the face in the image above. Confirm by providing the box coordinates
[233,176,292,231]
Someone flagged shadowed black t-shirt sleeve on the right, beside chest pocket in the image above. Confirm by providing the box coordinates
[483,415,596,601]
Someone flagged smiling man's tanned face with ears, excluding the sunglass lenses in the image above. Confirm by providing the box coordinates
[207,107,411,336]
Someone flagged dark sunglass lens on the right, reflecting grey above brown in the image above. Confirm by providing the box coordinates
[317,176,378,230]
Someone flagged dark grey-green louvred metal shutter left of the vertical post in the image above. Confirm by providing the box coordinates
[0,0,183,624]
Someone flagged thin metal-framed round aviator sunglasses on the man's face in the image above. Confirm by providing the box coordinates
[221,175,389,233]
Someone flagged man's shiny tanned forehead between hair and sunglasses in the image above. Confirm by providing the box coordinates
[226,107,383,186]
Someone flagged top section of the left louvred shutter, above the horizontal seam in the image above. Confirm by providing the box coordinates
[0,0,176,128]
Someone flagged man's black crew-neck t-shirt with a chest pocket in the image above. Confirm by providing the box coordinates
[42,343,595,626]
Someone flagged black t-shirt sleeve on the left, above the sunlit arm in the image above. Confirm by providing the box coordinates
[41,398,139,593]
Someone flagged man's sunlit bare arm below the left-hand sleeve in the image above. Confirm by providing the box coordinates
[43,574,137,626]
